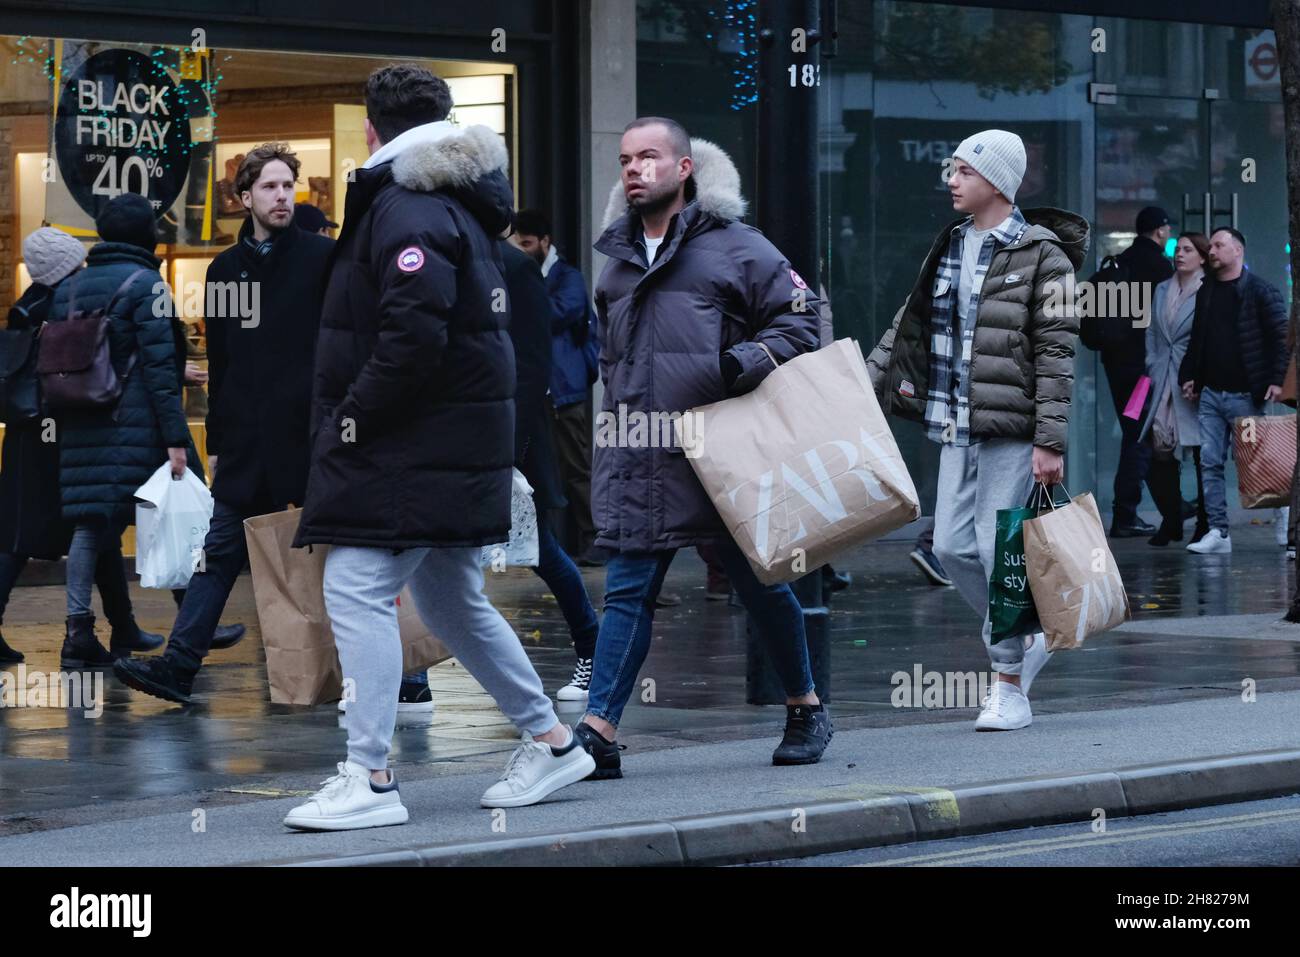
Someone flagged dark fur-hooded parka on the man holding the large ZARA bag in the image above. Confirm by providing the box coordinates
[592,139,822,551]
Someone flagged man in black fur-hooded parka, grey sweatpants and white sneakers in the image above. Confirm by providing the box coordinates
[285,64,593,830]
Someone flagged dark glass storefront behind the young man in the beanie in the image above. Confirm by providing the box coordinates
[637,0,1290,514]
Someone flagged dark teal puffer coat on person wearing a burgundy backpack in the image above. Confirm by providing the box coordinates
[48,243,203,527]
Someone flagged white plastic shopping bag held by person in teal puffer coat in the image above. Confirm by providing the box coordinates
[135,464,212,588]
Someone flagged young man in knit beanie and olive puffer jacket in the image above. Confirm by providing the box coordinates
[867,130,1088,731]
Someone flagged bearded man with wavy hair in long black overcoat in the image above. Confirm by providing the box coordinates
[113,143,334,703]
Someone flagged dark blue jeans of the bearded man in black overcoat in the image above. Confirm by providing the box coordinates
[165,499,258,671]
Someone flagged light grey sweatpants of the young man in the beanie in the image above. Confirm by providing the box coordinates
[935,438,1034,675]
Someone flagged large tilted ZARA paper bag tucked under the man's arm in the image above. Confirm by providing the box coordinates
[676,339,920,585]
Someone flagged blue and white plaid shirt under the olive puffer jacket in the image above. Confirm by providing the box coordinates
[926,207,1028,446]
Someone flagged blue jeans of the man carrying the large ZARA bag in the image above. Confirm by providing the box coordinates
[586,541,813,726]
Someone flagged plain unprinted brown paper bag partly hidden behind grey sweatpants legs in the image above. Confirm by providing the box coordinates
[244,508,451,705]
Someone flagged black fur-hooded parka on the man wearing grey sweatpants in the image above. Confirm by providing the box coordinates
[296,124,515,549]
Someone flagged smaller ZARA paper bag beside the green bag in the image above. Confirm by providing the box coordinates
[1023,492,1130,651]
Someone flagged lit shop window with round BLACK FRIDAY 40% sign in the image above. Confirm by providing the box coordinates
[0,36,520,551]
